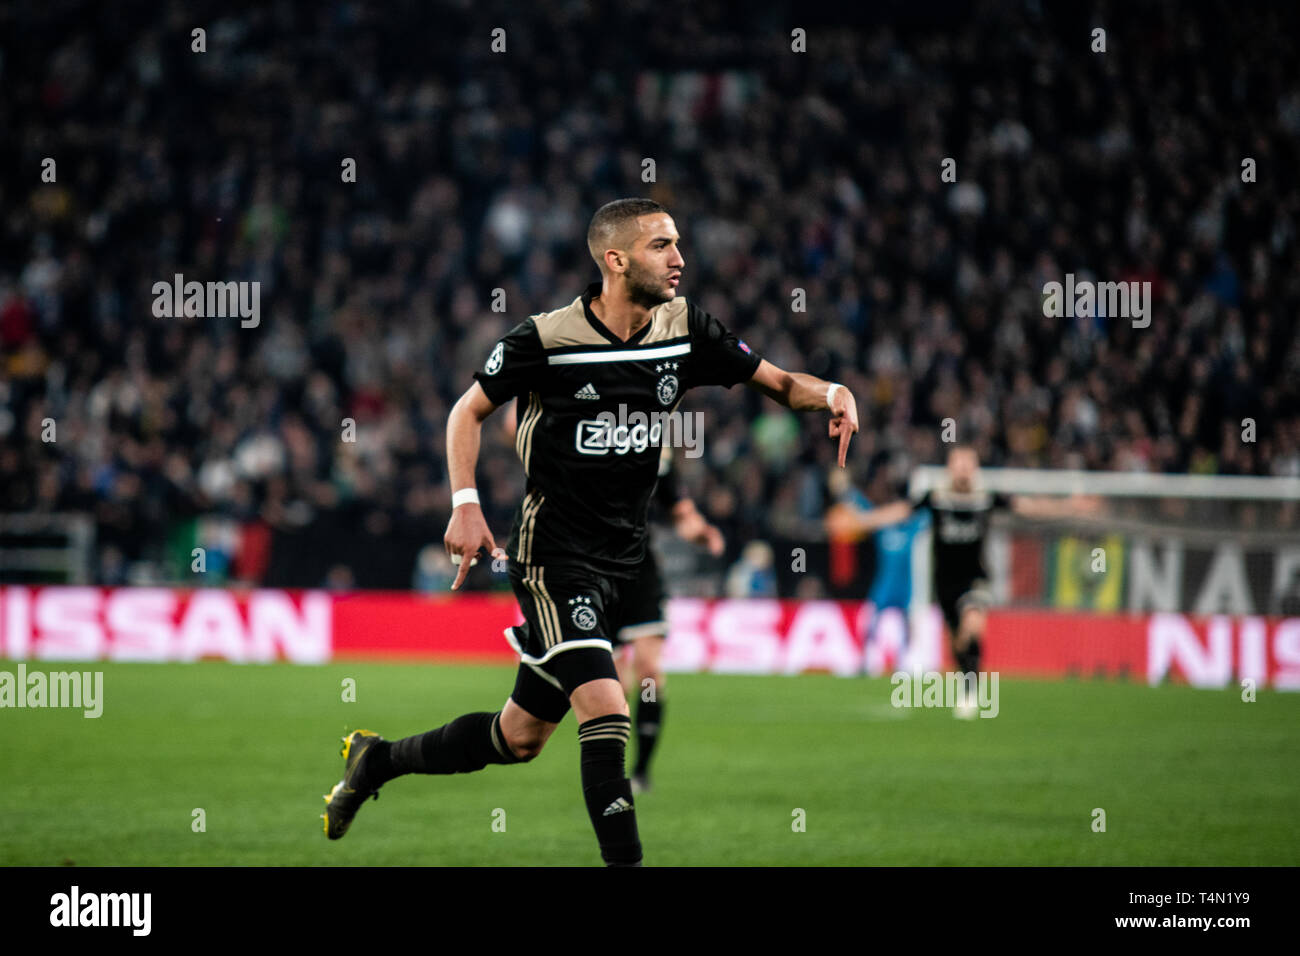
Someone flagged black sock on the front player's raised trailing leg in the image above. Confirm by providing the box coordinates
[365,711,523,787]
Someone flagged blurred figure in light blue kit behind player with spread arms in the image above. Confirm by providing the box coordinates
[826,455,930,672]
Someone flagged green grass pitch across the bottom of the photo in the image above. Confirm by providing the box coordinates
[0,662,1300,866]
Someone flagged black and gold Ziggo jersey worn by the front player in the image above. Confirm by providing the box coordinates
[475,282,759,575]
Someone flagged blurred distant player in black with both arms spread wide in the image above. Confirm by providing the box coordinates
[852,445,1096,719]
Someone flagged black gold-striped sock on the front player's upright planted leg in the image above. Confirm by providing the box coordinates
[577,714,641,866]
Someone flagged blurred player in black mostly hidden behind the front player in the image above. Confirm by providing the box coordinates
[614,446,725,793]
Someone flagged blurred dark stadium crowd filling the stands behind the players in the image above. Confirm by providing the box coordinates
[0,0,1300,587]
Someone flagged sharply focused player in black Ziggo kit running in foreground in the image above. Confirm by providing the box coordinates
[324,199,858,866]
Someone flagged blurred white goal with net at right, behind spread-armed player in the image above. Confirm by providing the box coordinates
[866,467,1300,689]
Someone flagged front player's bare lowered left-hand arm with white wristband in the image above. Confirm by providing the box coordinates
[442,382,506,591]
